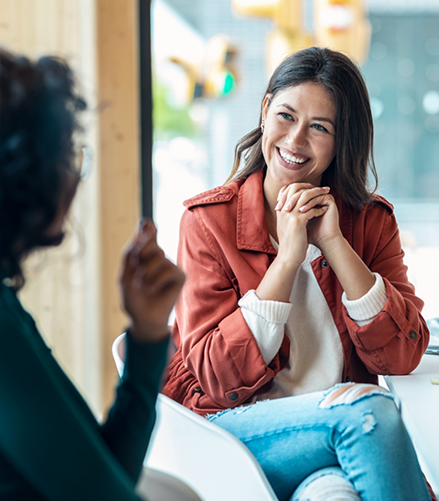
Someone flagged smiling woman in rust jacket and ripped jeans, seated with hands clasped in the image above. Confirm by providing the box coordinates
[164,47,436,501]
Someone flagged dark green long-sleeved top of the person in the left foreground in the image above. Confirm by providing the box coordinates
[0,282,168,501]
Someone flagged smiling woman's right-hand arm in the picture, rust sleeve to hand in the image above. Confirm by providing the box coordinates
[282,189,429,374]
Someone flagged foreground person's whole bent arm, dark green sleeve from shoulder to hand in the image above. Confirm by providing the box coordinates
[0,223,183,501]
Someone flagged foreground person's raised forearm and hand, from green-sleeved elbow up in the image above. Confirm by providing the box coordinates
[102,220,184,480]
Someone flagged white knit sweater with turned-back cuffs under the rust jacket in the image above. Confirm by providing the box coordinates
[238,239,387,400]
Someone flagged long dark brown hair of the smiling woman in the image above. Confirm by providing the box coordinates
[226,47,378,209]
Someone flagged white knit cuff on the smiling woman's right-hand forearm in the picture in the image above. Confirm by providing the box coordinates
[341,273,387,327]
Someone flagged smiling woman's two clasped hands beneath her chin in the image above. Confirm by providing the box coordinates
[275,183,342,264]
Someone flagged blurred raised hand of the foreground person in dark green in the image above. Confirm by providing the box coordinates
[120,220,184,341]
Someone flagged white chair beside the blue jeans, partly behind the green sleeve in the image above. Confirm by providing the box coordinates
[112,334,277,501]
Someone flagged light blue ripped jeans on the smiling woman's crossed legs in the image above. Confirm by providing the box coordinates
[207,383,430,501]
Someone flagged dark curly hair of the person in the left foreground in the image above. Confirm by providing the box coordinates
[0,49,86,289]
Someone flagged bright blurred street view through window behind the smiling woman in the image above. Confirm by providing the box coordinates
[153,0,439,317]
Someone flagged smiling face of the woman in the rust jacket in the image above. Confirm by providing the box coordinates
[262,82,336,195]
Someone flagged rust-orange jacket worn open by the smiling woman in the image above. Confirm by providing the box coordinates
[163,173,429,416]
